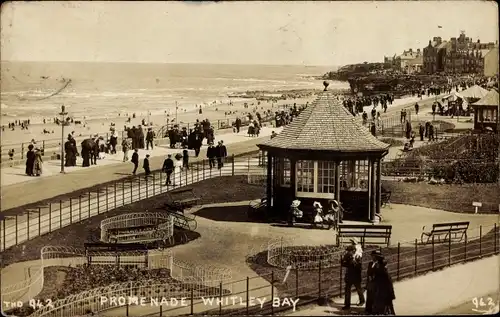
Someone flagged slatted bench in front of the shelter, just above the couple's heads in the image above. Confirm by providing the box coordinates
[337,224,392,247]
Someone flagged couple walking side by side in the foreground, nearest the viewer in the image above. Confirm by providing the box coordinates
[341,238,396,315]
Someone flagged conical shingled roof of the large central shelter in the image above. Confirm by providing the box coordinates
[258,91,389,152]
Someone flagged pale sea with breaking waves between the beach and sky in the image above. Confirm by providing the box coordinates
[0,61,347,124]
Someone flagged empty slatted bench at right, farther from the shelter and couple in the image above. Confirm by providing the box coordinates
[420,221,470,244]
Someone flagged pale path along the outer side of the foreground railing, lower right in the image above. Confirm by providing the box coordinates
[284,255,500,316]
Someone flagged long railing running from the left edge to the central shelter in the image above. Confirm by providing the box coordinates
[0,151,262,251]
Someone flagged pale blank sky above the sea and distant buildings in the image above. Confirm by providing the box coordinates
[0,1,498,66]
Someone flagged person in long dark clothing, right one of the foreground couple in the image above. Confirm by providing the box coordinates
[365,250,396,315]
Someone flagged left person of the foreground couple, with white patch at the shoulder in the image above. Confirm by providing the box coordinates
[341,238,365,310]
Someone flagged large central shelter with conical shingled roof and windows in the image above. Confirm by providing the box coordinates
[258,91,389,221]
